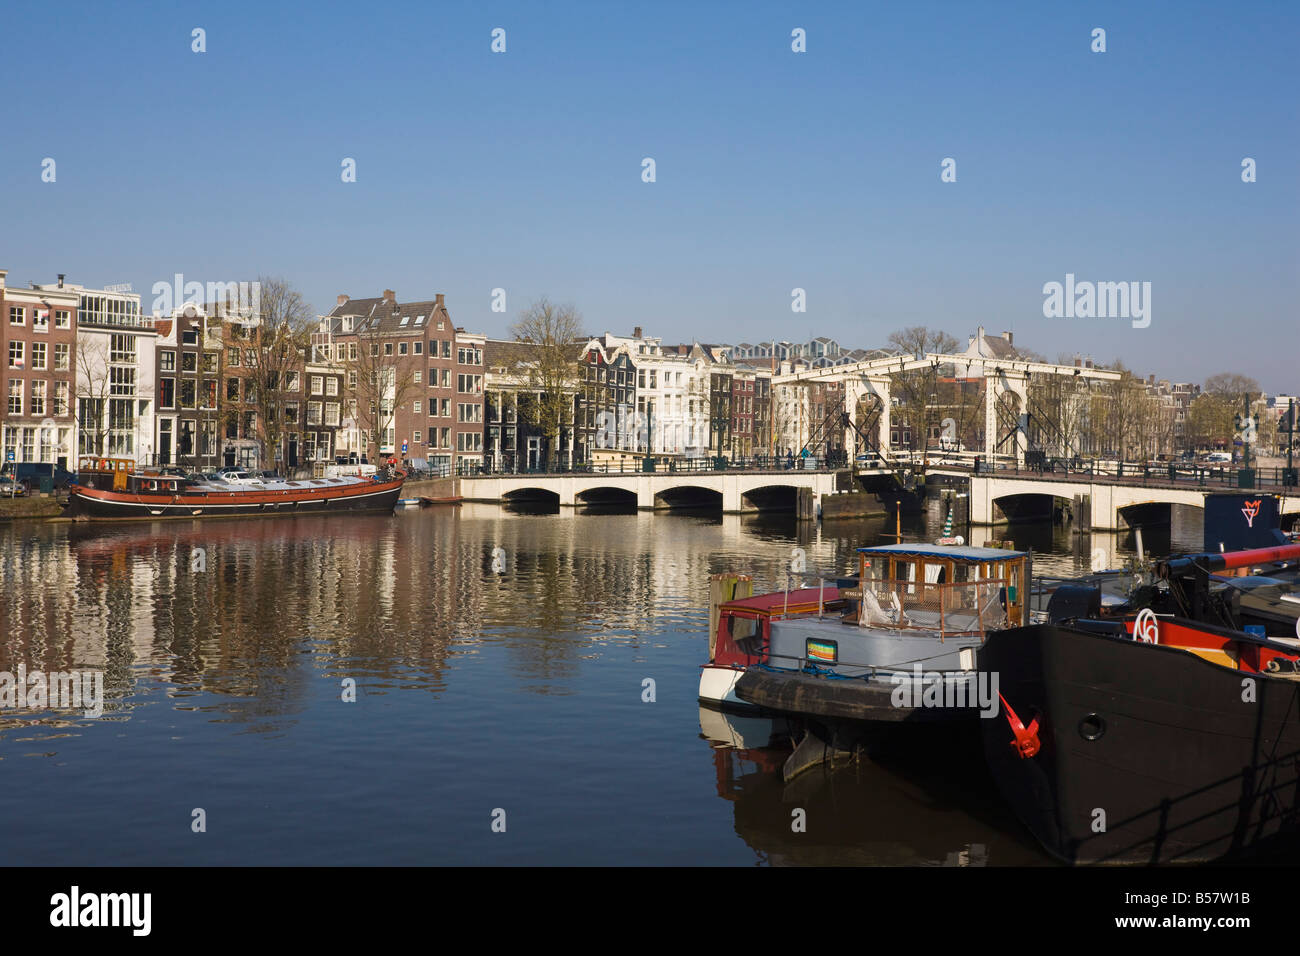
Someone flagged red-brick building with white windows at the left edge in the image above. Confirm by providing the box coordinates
[0,271,79,467]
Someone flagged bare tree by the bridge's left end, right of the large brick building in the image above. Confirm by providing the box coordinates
[510,298,588,467]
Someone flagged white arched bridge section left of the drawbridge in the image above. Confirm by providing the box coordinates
[460,471,836,515]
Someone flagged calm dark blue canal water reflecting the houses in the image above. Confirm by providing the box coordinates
[0,502,1200,865]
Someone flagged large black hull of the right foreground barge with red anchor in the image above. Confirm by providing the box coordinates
[980,624,1300,864]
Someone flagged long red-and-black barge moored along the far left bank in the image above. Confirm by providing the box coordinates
[65,459,406,520]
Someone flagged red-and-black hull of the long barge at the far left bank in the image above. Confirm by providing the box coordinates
[65,480,402,520]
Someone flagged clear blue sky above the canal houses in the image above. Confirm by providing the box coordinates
[0,0,1300,392]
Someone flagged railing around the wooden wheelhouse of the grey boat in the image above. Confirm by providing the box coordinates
[854,578,1009,640]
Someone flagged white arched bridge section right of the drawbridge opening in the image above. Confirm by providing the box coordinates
[946,468,1300,531]
